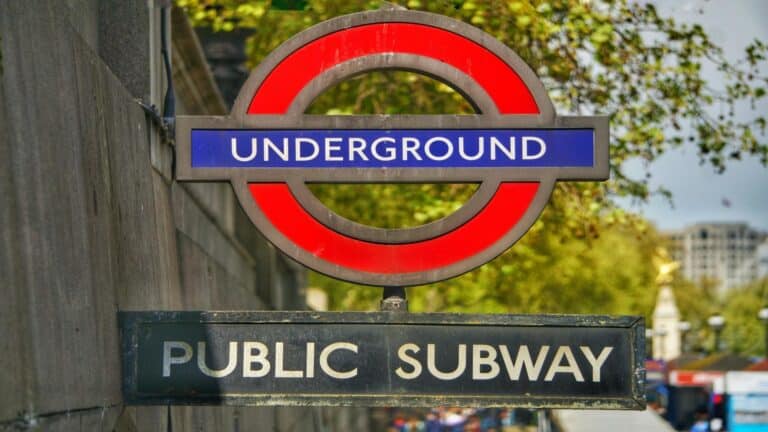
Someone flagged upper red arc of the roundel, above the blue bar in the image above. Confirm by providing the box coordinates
[248,22,539,114]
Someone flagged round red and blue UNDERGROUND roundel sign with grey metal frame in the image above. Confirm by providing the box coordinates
[176,10,609,286]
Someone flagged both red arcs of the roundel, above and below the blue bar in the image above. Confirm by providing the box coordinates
[248,19,539,280]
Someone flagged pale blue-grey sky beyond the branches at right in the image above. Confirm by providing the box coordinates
[621,0,768,231]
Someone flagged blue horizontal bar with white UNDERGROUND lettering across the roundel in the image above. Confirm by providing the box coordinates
[191,129,595,168]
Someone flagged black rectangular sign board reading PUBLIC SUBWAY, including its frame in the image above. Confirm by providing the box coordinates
[120,312,645,409]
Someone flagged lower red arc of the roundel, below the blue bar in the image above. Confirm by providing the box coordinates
[249,183,538,274]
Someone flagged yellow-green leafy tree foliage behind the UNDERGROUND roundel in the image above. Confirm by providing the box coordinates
[177,0,768,314]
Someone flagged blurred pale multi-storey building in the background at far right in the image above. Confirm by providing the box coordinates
[669,223,766,293]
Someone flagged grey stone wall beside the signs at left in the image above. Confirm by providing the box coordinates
[0,0,365,432]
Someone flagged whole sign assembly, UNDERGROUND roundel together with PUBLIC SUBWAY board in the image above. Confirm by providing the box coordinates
[129,10,645,409]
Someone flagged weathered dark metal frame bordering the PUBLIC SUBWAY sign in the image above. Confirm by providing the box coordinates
[119,311,645,410]
